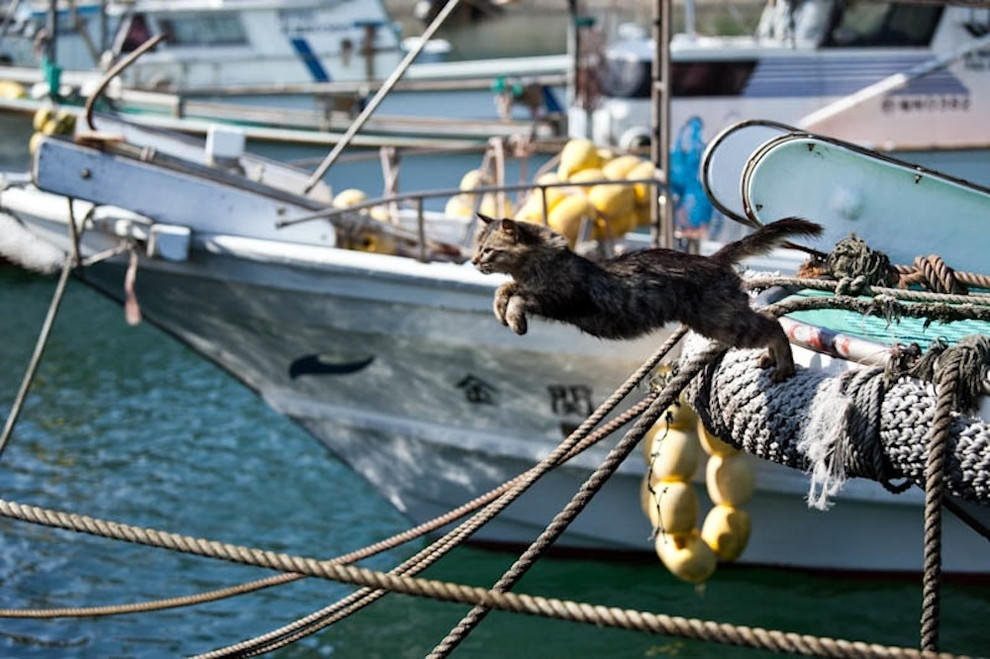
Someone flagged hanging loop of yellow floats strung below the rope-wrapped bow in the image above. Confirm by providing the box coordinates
[641,404,755,584]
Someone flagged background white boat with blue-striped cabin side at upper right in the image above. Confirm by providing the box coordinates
[568,0,990,237]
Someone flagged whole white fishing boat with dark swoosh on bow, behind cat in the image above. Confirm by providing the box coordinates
[0,105,990,573]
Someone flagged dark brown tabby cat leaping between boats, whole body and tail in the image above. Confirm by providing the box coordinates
[471,215,822,381]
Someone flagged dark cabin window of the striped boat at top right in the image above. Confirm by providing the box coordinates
[825,1,943,47]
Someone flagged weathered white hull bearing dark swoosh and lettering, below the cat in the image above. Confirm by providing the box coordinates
[5,199,990,573]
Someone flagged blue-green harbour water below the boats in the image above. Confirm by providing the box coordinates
[0,268,990,658]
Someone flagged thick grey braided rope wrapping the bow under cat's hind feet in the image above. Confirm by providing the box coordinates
[687,345,990,505]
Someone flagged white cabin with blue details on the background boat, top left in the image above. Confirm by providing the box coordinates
[1,0,402,89]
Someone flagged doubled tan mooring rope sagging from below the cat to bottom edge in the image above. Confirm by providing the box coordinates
[202,327,687,657]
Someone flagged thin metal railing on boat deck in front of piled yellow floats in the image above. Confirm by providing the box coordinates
[275,176,667,263]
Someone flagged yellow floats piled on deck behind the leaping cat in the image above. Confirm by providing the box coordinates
[333,139,657,249]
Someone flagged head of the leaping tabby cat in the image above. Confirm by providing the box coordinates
[471,213,567,274]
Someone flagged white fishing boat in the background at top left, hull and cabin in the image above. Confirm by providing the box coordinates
[0,0,567,152]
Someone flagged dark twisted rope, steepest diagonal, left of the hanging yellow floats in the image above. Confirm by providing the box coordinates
[429,345,725,657]
